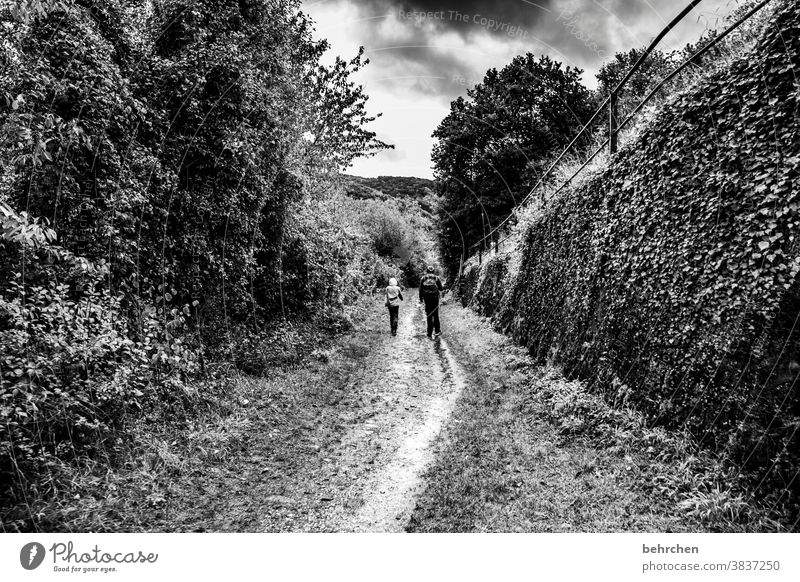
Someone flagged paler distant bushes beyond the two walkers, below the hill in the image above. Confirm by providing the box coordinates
[254,171,438,318]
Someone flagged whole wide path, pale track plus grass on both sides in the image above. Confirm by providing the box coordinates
[153,290,698,532]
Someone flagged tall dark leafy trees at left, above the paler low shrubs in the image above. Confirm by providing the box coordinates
[0,0,388,337]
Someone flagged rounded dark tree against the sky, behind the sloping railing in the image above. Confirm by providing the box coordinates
[433,53,593,266]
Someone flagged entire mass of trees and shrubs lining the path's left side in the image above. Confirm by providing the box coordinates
[0,0,389,527]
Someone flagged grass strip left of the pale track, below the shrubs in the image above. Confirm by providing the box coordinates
[0,304,379,532]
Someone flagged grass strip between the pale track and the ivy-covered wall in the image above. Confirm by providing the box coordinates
[407,306,780,532]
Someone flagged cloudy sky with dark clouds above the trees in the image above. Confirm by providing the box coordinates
[304,0,740,177]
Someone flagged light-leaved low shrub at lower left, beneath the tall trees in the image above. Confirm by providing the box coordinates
[0,241,209,529]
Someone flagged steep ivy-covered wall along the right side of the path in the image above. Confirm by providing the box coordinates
[495,2,800,504]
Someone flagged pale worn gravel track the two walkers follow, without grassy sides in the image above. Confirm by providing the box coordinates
[262,291,464,532]
